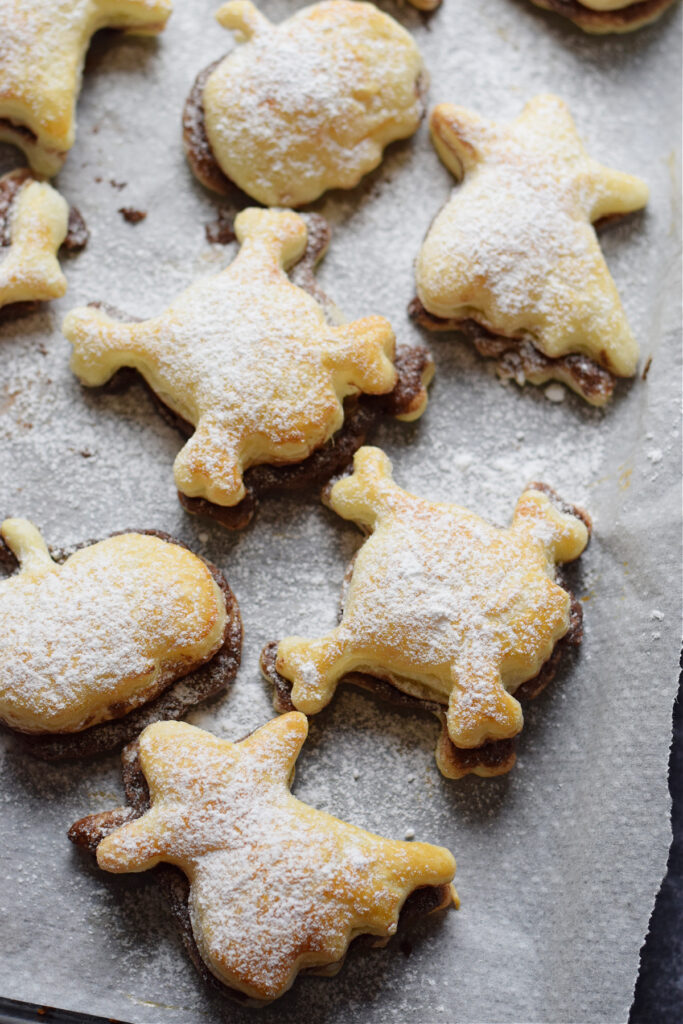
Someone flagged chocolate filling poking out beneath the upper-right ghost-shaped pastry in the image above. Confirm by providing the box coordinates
[408,298,615,406]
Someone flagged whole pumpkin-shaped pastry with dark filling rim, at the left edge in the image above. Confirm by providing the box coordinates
[0,519,242,758]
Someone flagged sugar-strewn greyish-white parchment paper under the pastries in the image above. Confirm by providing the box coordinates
[0,0,681,1024]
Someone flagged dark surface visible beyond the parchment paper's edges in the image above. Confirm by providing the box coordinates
[0,655,683,1024]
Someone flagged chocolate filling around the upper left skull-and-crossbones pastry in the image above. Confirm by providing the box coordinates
[82,220,432,529]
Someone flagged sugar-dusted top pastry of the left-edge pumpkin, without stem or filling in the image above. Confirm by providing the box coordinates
[0,535,224,732]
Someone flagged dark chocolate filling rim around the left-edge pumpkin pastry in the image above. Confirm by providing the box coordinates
[0,529,242,761]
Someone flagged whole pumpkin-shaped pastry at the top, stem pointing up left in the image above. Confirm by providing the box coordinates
[183,0,426,207]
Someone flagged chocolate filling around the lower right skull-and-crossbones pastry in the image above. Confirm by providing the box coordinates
[260,482,591,778]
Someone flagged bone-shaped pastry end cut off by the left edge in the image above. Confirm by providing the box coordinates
[0,169,88,312]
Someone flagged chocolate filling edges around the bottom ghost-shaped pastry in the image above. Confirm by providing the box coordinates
[68,741,452,1007]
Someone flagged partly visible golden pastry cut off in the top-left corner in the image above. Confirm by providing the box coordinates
[0,0,172,177]
